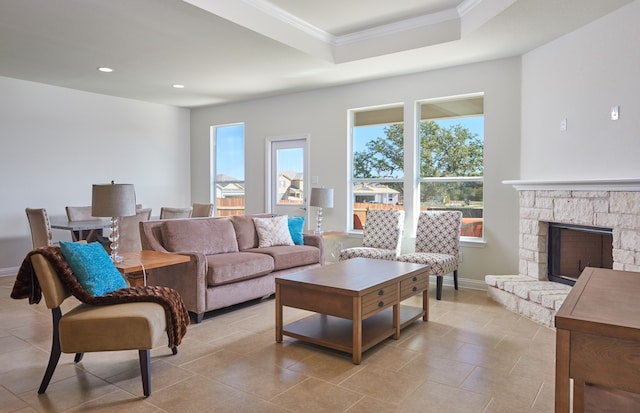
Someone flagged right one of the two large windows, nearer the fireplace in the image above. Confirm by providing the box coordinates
[418,96,484,238]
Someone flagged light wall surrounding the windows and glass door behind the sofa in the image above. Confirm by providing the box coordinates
[191,58,521,284]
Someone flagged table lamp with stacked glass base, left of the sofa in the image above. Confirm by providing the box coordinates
[91,181,136,263]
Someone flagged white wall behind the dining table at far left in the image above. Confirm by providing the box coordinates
[0,77,191,274]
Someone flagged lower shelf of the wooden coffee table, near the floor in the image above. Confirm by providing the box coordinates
[282,305,424,354]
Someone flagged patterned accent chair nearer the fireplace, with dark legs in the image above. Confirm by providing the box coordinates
[398,211,462,300]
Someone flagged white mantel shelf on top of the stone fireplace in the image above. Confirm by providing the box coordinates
[502,178,640,191]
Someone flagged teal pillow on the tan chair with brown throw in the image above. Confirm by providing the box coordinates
[60,241,128,296]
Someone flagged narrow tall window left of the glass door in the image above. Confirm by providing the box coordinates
[210,123,245,216]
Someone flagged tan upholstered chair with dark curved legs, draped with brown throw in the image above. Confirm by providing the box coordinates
[31,253,172,397]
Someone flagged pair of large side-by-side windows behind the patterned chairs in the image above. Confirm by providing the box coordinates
[351,94,484,238]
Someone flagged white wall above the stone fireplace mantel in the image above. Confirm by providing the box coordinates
[524,1,640,180]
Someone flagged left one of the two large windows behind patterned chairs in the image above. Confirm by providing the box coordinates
[351,106,404,229]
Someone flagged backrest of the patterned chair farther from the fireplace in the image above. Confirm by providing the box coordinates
[362,209,404,254]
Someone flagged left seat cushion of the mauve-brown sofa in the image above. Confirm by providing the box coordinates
[207,252,274,285]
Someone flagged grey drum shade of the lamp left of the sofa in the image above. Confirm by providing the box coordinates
[91,182,136,217]
